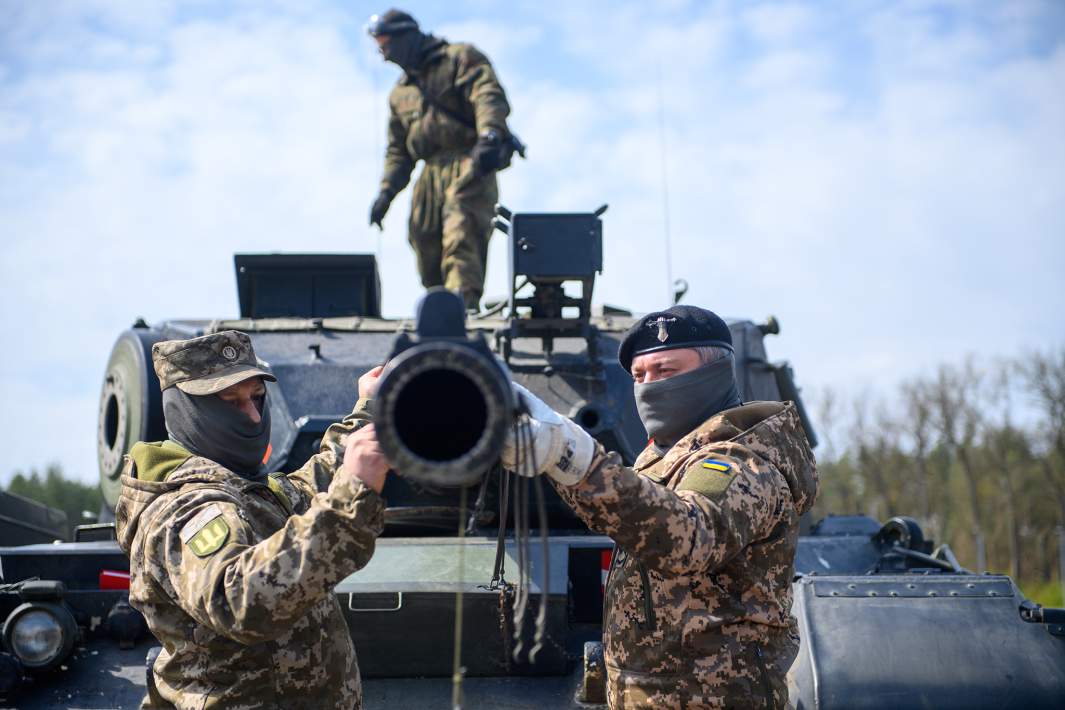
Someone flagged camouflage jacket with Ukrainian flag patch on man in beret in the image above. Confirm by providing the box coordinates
[556,402,818,708]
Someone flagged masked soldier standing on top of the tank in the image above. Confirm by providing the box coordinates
[366,10,513,311]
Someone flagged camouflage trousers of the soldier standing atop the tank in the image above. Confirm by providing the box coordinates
[409,152,499,307]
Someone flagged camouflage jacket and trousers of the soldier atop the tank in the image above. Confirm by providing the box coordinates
[381,37,510,304]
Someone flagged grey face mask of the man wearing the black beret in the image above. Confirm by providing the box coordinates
[634,353,740,448]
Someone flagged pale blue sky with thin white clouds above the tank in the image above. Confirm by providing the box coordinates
[0,0,1065,482]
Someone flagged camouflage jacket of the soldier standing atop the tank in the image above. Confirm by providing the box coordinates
[381,37,510,196]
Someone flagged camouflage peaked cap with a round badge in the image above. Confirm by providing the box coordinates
[151,330,277,395]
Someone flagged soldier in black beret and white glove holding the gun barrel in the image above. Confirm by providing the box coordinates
[504,307,818,708]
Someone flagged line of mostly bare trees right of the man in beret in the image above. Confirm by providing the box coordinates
[812,349,1065,604]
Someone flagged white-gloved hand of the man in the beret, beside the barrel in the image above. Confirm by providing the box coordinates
[499,383,595,485]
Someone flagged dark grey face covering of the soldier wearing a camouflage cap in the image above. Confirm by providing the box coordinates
[163,386,269,480]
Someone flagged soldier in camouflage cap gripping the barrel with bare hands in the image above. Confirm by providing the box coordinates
[115,331,388,710]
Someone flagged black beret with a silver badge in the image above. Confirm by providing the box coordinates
[618,306,733,373]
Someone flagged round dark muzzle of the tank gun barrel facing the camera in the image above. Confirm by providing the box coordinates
[375,287,514,486]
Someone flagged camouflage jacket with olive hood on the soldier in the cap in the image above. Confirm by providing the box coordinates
[115,400,383,710]
